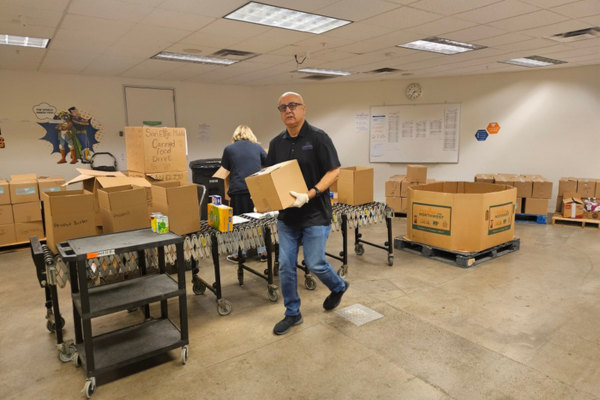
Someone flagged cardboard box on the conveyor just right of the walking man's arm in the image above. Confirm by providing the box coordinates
[338,167,374,206]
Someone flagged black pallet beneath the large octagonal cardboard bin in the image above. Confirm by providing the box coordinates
[394,238,521,268]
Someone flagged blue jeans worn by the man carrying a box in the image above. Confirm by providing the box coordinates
[277,221,345,317]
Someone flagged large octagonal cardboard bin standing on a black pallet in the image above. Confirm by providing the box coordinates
[407,182,517,253]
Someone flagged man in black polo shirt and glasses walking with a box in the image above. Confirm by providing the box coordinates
[267,92,349,335]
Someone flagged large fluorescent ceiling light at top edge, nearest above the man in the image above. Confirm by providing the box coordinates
[223,1,352,34]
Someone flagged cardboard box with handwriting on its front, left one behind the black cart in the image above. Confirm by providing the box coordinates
[42,190,97,253]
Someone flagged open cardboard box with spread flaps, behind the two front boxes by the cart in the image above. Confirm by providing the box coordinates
[65,168,152,226]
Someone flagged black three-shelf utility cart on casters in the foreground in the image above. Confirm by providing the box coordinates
[58,229,189,398]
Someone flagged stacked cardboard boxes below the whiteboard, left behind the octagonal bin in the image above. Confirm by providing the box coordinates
[385,165,435,214]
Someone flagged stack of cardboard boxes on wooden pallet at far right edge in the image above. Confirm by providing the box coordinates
[556,177,600,219]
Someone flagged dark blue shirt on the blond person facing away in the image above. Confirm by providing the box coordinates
[221,140,267,196]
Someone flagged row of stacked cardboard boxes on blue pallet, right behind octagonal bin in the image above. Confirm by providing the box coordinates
[475,174,552,215]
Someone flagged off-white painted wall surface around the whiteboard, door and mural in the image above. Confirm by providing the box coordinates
[0,65,600,209]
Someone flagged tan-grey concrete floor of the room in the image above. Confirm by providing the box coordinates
[0,219,600,400]
